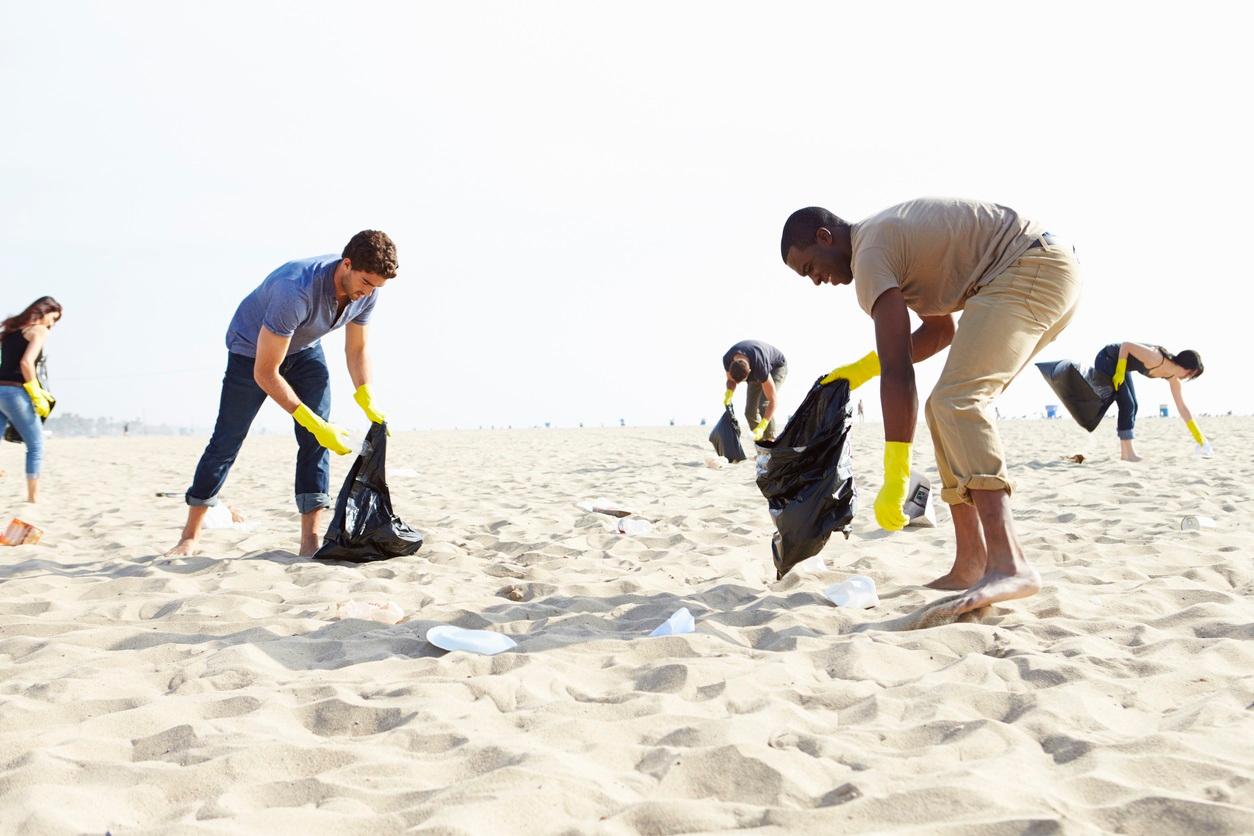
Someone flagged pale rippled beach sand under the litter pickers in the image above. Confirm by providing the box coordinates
[0,417,1254,836]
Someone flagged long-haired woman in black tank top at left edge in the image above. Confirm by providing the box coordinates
[0,296,61,503]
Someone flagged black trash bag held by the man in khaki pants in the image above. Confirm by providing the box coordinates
[757,380,858,579]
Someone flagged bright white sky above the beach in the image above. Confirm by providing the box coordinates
[0,0,1254,429]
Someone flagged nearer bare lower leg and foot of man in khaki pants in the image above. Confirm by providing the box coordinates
[942,490,1041,617]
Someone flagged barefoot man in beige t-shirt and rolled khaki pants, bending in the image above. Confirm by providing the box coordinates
[780,198,1080,619]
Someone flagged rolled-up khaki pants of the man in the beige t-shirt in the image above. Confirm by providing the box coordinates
[925,244,1080,505]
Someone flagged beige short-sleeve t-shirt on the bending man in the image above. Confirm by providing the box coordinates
[851,198,1046,316]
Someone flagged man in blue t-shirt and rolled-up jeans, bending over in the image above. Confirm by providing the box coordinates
[167,229,396,556]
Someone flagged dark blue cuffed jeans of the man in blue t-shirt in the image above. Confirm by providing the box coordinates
[185,346,331,514]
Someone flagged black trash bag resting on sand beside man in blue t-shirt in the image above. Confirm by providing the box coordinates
[314,424,423,563]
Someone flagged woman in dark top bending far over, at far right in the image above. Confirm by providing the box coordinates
[1093,342,1210,461]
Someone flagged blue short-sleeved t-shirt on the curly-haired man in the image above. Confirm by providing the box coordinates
[227,254,379,357]
